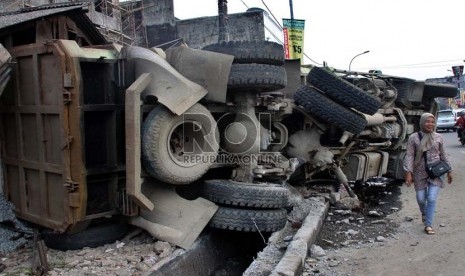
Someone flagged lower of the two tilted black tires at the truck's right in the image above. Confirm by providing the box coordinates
[294,85,367,134]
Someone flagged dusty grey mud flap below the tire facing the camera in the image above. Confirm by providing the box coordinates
[130,181,218,249]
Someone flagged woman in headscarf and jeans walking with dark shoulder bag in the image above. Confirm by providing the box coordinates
[404,113,452,235]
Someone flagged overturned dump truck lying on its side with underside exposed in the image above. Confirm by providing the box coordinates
[0,39,457,249]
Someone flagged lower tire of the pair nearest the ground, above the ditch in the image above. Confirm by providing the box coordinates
[209,206,287,232]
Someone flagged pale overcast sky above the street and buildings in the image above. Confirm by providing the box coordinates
[173,0,465,80]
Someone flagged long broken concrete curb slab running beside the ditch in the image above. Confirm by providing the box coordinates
[270,198,329,276]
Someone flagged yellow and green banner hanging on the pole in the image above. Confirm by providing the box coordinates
[283,19,305,60]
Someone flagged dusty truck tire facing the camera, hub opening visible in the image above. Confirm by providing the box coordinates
[142,103,219,185]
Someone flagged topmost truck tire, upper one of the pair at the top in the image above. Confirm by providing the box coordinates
[202,41,284,66]
